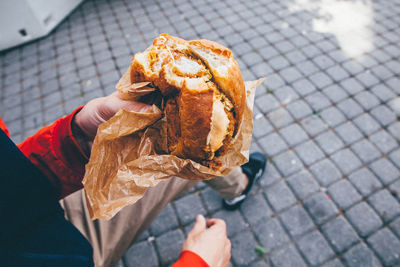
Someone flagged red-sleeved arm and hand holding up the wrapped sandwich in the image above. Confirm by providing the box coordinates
[18,93,149,199]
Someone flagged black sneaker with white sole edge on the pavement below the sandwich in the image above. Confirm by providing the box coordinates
[222,152,267,210]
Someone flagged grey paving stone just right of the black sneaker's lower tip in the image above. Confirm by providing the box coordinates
[240,194,272,225]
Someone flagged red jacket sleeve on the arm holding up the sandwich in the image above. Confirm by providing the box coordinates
[18,107,88,199]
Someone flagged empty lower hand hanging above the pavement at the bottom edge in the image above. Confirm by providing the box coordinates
[182,215,231,267]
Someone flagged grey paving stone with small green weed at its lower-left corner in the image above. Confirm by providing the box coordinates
[253,218,290,251]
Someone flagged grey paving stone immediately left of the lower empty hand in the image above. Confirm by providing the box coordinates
[155,229,185,265]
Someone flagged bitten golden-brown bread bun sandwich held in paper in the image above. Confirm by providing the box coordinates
[128,34,245,168]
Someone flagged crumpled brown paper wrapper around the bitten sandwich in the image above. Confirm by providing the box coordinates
[83,70,264,220]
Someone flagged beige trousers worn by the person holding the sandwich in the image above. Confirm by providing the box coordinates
[61,168,245,266]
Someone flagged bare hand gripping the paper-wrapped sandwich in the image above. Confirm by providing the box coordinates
[72,92,151,153]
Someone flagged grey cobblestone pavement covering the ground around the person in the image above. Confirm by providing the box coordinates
[0,0,400,266]
